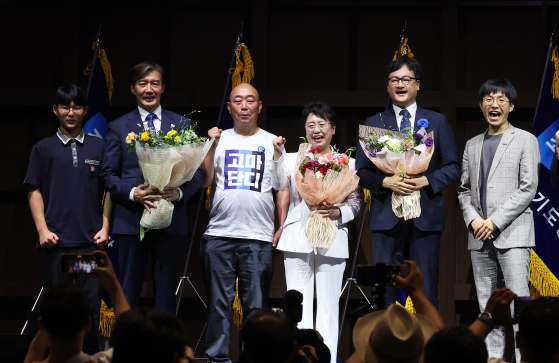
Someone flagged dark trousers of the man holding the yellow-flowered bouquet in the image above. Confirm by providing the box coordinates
[115,230,185,314]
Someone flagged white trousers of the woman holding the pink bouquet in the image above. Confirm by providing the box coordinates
[283,252,345,363]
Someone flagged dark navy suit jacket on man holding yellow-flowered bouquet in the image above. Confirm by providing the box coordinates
[101,108,204,235]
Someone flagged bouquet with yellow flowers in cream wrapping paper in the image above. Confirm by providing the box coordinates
[126,119,214,229]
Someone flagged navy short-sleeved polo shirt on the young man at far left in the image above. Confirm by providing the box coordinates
[24,130,105,248]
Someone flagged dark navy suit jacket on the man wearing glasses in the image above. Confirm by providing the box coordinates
[355,106,460,231]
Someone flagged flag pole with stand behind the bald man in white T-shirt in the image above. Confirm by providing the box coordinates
[175,23,243,315]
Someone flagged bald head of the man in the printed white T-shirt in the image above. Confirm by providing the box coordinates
[227,83,262,128]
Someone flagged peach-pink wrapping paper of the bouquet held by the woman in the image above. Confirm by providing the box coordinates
[295,143,359,253]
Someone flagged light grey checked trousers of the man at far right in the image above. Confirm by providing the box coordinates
[471,242,530,362]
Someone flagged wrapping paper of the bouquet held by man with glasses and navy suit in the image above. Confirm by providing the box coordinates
[359,125,435,220]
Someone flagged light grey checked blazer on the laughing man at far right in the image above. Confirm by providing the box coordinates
[458,124,540,250]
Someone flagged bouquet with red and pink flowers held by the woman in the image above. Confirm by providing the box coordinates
[295,143,359,253]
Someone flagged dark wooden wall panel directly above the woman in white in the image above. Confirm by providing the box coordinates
[268,7,349,91]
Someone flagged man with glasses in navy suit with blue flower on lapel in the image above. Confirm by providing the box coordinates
[356,56,460,309]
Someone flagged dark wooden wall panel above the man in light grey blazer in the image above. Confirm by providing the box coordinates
[457,6,549,99]
